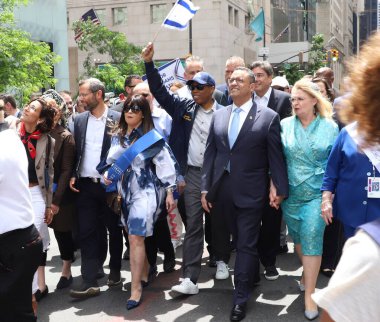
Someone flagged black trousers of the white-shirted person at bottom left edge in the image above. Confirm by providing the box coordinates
[0,225,42,322]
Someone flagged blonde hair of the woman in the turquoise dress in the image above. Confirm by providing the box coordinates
[292,79,333,119]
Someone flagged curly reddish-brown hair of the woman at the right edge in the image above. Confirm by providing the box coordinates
[339,32,380,145]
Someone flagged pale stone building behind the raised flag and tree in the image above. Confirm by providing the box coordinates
[67,0,270,89]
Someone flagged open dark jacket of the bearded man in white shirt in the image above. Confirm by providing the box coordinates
[73,109,120,178]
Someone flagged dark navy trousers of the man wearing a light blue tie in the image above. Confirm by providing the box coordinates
[211,173,264,305]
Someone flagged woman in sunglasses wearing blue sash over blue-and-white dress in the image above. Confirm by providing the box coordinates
[98,95,178,310]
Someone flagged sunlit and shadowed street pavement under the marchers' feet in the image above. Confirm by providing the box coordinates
[38,232,328,322]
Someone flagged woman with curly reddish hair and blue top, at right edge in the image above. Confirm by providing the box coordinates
[321,33,380,238]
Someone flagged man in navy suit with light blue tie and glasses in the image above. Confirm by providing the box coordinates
[201,67,288,321]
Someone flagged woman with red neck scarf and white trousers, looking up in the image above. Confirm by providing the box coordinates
[18,98,55,308]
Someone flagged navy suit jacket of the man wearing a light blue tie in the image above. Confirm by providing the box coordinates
[201,102,288,208]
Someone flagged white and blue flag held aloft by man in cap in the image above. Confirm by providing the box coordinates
[162,0,199,30]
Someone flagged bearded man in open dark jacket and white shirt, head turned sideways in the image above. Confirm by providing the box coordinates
[70,78,123,298]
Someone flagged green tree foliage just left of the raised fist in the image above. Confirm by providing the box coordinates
[73,21,145,94]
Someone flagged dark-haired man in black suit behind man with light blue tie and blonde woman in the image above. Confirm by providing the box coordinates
[251,61,292,281]
